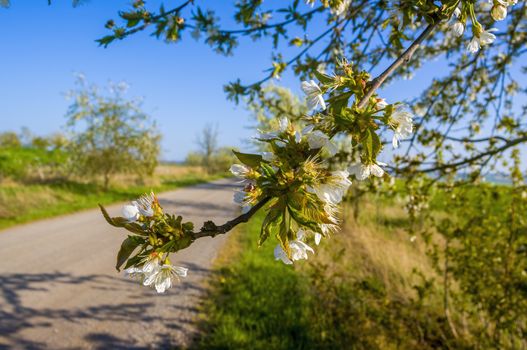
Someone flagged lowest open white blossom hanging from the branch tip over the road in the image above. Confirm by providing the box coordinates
[124,253,188,293]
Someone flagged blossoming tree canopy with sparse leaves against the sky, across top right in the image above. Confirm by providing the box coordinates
[95,0,527,183]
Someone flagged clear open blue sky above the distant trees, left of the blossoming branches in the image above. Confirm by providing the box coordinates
[0,0,486,160]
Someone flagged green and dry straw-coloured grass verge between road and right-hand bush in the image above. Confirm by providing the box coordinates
[195,196,459,349]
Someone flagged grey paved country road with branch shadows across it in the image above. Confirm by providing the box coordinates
[0,180,236,349]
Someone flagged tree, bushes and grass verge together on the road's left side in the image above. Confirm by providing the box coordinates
[0,76,230,229]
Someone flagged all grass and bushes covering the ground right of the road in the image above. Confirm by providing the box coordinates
[195,179,527,349]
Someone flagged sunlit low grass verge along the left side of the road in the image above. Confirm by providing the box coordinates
[0,166,222,229]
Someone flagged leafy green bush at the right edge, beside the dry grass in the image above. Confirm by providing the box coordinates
[422,152,527,349]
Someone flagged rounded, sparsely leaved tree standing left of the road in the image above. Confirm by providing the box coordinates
[66,76,161,189]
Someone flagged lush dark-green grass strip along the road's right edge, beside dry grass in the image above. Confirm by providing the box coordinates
[196,215,316,349]
